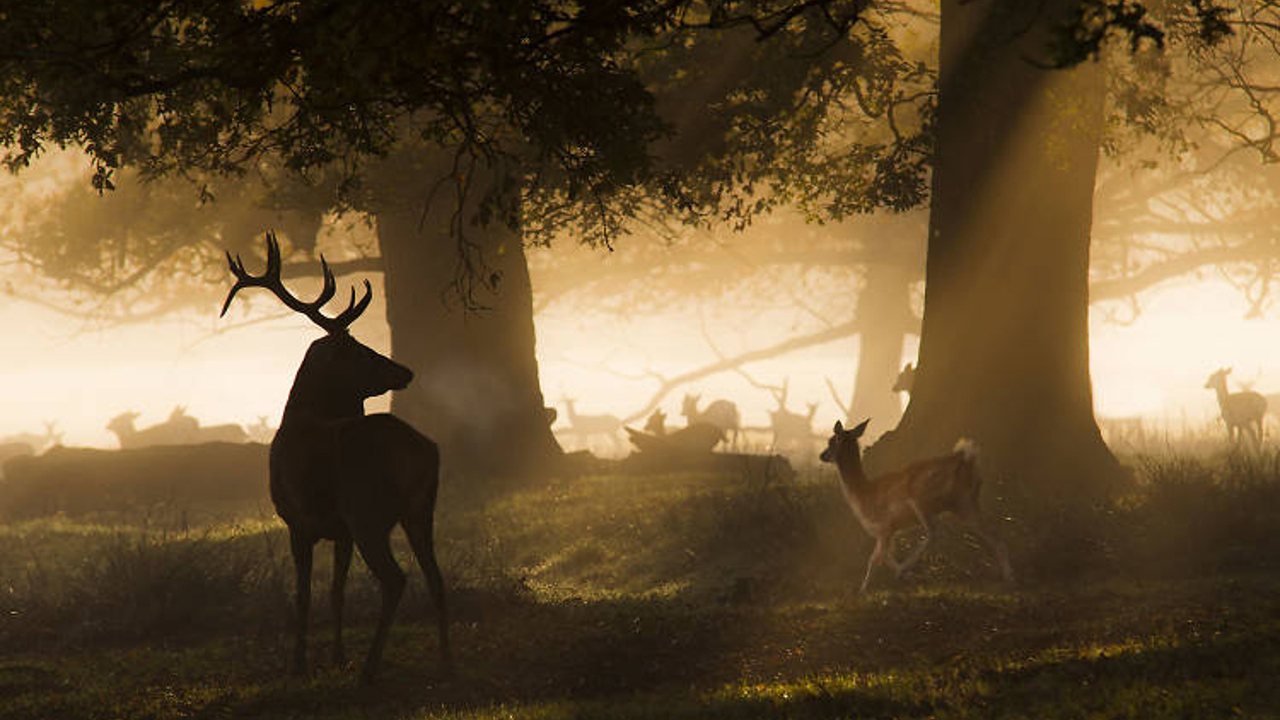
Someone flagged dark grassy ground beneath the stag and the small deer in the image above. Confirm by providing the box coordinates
[0,445,1280,720]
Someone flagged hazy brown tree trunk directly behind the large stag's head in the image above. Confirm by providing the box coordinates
[375,193,561,483]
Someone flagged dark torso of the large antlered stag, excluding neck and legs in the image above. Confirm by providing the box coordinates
[271,413,440,538]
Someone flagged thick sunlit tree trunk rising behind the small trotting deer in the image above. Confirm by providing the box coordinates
[868,0,1120,495]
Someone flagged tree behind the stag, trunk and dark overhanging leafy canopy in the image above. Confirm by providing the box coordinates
[0,0,923,475]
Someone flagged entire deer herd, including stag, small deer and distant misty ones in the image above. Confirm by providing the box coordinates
[0,233,1280,682]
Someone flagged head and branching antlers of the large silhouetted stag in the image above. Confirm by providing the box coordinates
[221,233,413,406]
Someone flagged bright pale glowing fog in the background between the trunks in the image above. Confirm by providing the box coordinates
[0,251,1259,447]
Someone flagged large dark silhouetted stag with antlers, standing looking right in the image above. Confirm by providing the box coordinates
[223,233,452,683]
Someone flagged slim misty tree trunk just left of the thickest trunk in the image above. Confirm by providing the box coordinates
[855,263,919,437]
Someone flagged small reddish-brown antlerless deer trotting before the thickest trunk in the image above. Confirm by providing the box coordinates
[818,420,1014,593]
